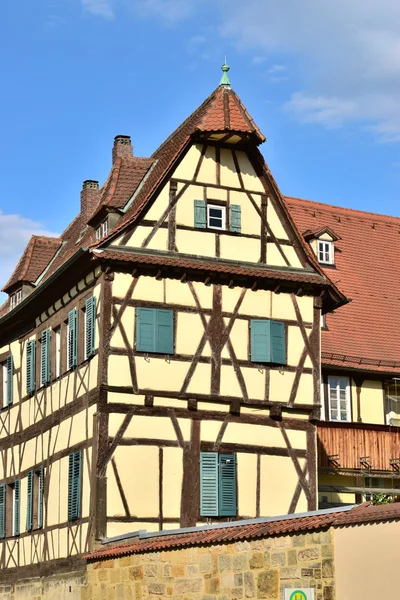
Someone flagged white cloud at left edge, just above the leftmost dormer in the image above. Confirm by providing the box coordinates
[0,210,58,303]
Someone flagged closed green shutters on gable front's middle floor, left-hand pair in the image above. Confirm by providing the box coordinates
[136,308,174,354]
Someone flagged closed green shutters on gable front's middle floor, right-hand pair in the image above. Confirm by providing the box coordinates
[250,319,286,365]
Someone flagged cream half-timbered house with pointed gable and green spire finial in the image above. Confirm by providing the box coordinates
[0,67,346,577]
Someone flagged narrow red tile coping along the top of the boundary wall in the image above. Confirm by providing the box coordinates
[84,502,400,562]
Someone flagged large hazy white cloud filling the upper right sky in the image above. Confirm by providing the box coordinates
[218,0,400,141]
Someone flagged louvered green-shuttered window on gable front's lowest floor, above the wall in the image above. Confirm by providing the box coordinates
[200,452,237,517]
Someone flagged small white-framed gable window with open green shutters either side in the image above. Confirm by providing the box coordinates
[194,200,242,233]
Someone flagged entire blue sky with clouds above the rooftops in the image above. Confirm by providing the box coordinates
[0,0,400,290]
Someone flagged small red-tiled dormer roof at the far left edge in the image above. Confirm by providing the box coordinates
[2,235,62,292]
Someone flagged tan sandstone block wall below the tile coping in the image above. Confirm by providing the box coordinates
[86,531,335,600]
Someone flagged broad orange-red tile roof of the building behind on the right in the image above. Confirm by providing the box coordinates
[286,198,400,372]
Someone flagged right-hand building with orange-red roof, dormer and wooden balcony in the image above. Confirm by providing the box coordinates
[286,198,400,507]
